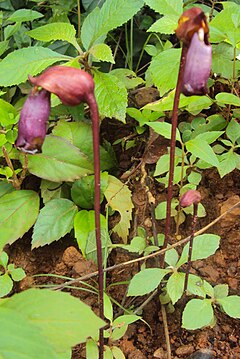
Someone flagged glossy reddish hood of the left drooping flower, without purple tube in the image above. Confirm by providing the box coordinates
[29,66,94,106]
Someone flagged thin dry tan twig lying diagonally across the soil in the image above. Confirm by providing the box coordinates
[52,201,240,290]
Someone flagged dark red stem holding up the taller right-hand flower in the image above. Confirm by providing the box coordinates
[161,44,188,266]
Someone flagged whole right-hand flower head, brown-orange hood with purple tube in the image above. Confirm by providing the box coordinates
[176,8,212,96]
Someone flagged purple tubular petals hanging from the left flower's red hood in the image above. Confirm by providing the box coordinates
[15,89,50,154]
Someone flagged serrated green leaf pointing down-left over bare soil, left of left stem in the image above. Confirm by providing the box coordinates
[32,198,77,248]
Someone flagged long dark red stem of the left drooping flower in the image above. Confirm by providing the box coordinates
[87,94,104,359]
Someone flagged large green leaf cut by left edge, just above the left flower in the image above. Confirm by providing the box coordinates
[0,46,69,87]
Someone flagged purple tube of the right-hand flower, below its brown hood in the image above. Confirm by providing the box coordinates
[182,28,212,96]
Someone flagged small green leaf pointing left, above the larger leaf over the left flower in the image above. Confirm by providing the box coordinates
[27,22,80,50]
